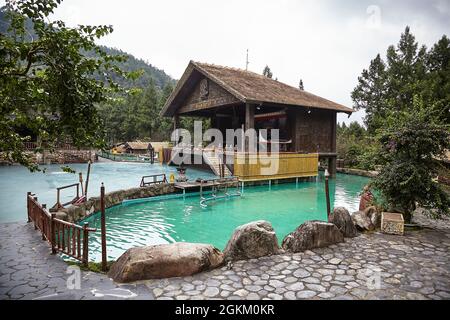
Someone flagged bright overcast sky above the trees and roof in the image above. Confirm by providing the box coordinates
[0,0,450,122]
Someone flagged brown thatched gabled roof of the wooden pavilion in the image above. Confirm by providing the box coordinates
[161,61,353,116]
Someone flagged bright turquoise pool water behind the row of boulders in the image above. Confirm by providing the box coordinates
[81,174,368,261]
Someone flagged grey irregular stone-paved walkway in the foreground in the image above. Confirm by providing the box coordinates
[0,218,450,299]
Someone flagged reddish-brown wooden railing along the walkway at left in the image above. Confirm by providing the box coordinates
[27,192,97,265]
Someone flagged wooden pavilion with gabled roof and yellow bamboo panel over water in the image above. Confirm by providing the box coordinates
[161,61,353,180]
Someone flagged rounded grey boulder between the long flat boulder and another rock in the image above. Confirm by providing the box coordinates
[223,221,280,261]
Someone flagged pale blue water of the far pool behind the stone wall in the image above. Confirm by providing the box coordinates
[0,162,214,223]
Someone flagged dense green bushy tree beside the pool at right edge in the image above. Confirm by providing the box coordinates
[373,96,450,222]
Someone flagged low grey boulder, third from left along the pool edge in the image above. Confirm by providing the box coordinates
[281,221,344,252]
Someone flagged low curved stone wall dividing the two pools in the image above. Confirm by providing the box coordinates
[57,183,175,222]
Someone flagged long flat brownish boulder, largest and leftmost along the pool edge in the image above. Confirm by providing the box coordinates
[108,242,223,282]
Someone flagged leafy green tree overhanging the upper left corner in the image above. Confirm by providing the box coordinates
[0,0,133,170]
